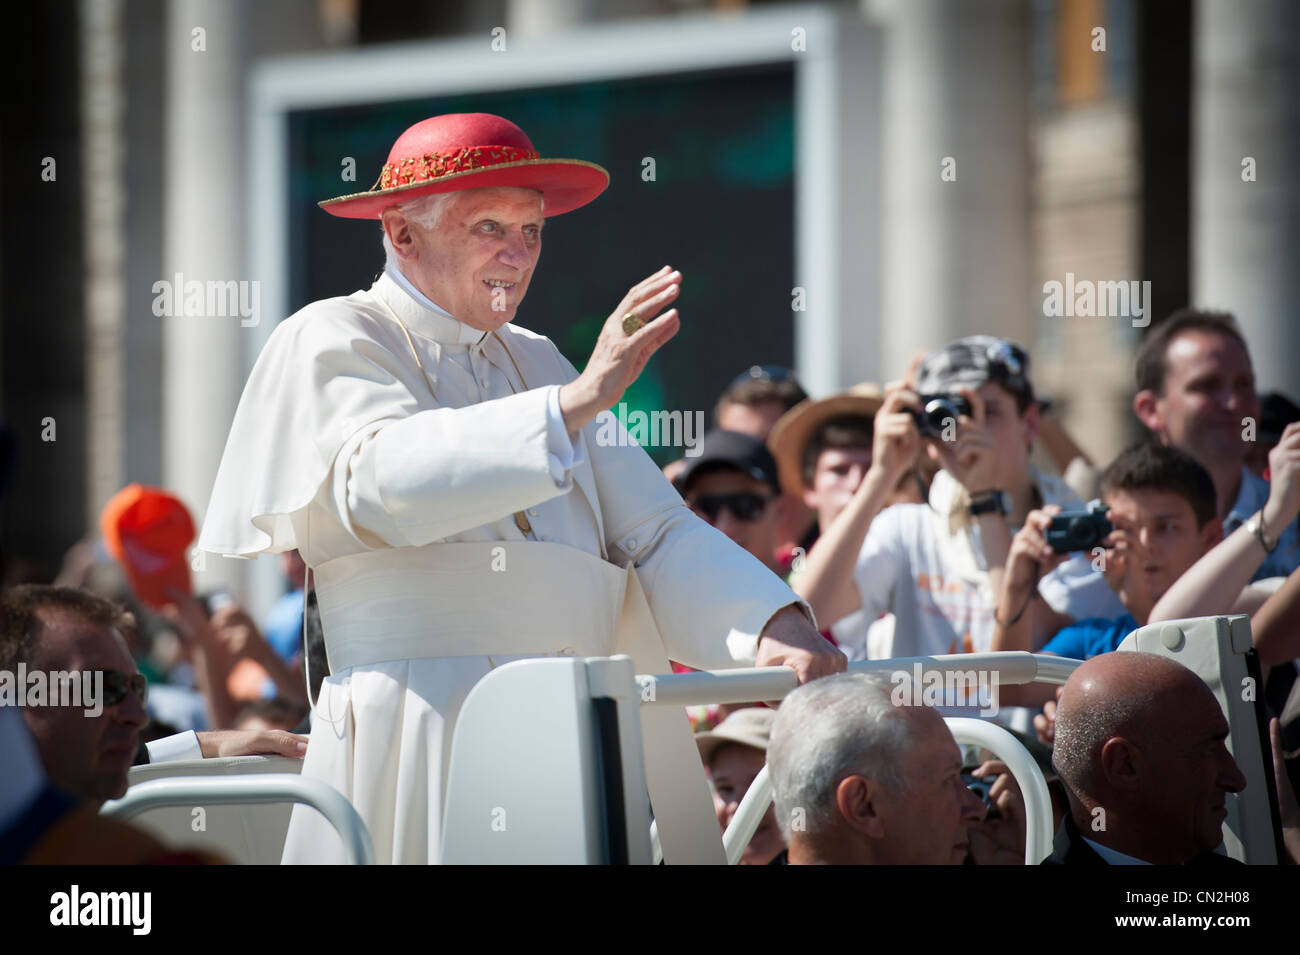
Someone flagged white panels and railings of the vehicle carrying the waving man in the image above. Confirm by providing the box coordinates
[104,617,1278,864]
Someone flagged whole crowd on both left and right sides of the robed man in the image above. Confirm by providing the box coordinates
[0,302,1300,864]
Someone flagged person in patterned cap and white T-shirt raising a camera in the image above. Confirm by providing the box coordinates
[796,335,1082,656]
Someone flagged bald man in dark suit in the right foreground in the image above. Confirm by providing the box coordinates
[1044,652,1245,865]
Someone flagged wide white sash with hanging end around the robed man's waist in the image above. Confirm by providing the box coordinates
[313,541,725,864]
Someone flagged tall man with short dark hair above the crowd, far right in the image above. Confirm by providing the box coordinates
[1134,308,1300,579]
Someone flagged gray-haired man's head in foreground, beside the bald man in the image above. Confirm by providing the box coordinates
[767,673,984,865]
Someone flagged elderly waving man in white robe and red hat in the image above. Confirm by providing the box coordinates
[199,113,845,863]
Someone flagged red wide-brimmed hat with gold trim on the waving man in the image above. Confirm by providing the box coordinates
[320,113,610,218]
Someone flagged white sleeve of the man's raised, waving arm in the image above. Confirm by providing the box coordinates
[348,385,582,547]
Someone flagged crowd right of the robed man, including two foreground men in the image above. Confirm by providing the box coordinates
[666,309,1300,864]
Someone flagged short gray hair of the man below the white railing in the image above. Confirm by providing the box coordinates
[767,673,913,842]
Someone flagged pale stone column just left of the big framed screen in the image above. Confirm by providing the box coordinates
[163,0,322,613]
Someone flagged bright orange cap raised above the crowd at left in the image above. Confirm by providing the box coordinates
[99,485,194,609]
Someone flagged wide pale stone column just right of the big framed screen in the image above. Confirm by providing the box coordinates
[865,0,1041,378]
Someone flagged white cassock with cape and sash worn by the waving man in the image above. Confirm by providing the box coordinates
[199,263,806,863]
